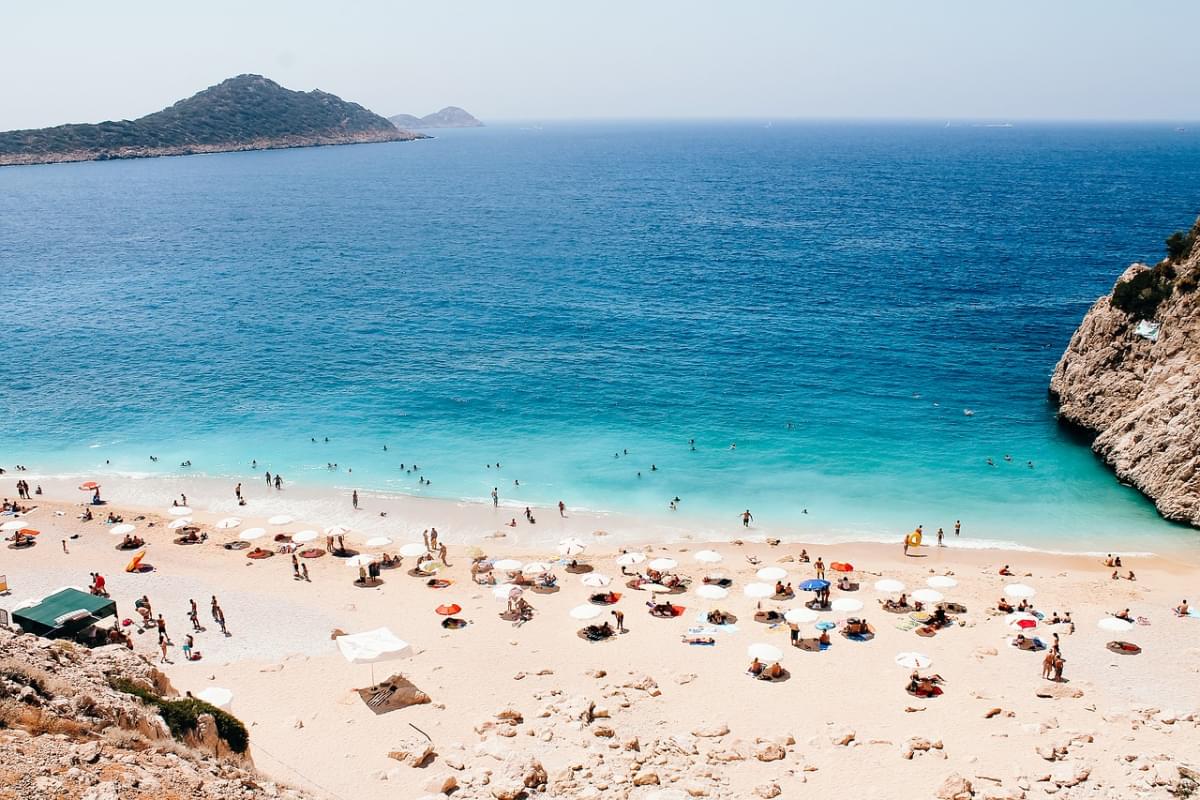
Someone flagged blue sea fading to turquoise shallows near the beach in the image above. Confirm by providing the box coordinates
[0,122,1200,549]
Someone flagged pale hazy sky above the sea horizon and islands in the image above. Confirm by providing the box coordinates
[0,0,1200,130]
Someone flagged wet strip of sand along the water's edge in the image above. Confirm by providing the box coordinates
[5,471,1200,566]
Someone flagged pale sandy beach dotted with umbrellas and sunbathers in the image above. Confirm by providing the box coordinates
[0,480,1200,799]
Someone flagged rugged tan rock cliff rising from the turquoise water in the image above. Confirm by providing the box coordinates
[1050,221,1200,527]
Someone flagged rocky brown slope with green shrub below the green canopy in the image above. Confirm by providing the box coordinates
[0,628,307,800]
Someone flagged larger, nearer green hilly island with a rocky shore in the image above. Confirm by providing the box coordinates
[0,74,426,166]
